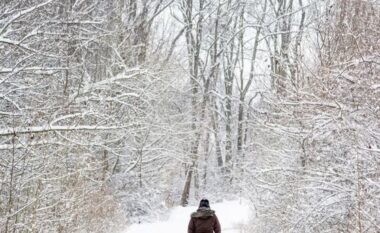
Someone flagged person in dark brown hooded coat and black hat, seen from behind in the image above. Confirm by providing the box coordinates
[187,199,222,233]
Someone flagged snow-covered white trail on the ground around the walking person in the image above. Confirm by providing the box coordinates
[123,198,251,233]
